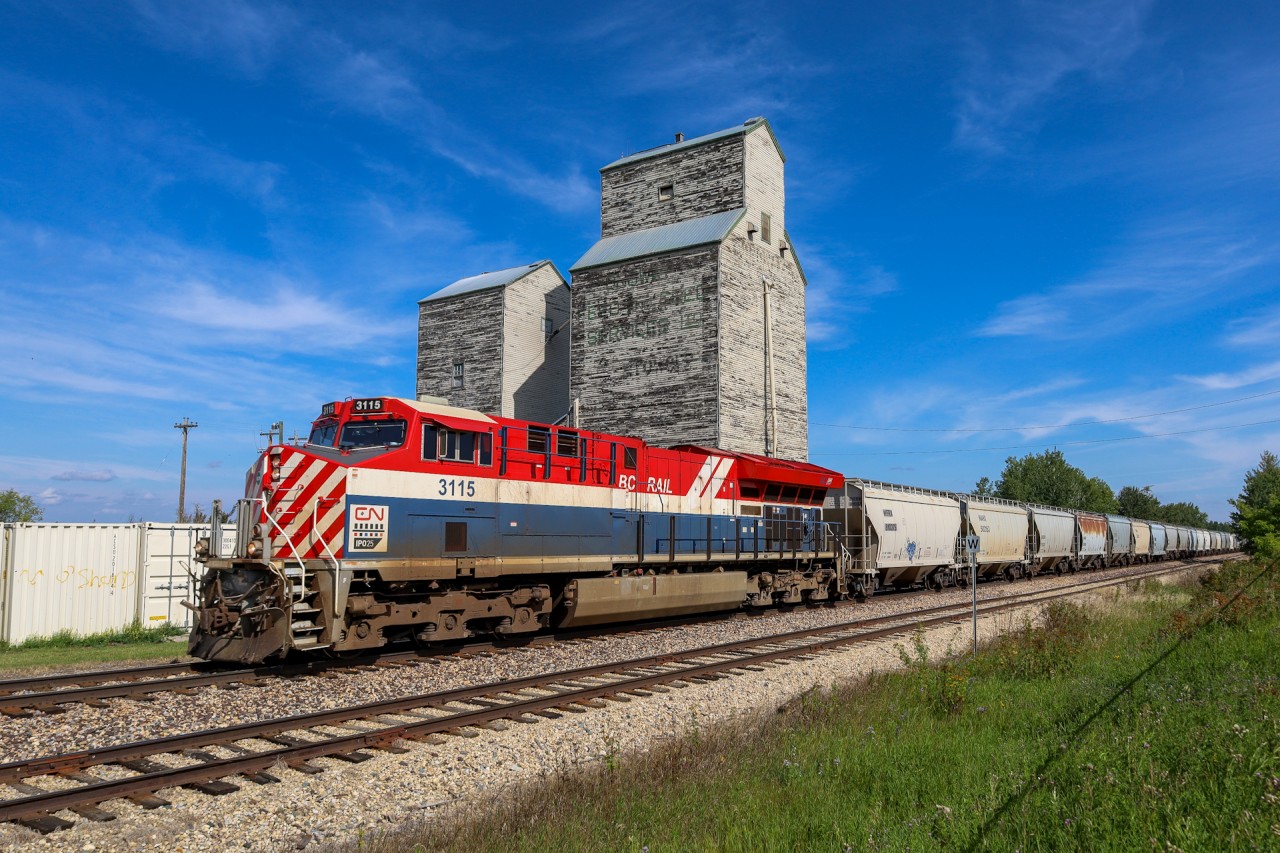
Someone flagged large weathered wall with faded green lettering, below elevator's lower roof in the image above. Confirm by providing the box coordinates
[572,246,719,446]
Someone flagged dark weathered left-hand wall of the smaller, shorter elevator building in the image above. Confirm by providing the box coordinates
[417,287,503,414]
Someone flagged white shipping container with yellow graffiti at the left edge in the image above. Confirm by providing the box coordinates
[0,524,141,643]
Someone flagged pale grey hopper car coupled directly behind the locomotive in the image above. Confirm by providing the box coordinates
[823,480,960,587]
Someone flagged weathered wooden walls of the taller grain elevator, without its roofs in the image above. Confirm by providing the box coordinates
[572,119,809,460]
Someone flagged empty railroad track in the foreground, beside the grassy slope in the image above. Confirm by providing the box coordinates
[0,564,1208,833]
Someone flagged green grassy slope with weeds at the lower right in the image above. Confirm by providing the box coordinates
[360,564,1280,853]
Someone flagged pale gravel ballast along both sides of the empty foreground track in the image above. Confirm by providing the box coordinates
[0,566,1204,850]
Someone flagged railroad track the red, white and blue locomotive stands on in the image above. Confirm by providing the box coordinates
[0,560,1223,717]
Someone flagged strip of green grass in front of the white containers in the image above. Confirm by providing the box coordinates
[0,622,187,672]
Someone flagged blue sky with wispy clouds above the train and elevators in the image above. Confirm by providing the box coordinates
[0,0,1280,521]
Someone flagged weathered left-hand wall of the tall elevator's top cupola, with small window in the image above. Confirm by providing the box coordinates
[600,133,747,237]
